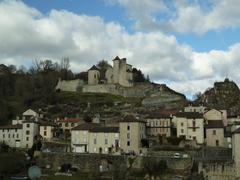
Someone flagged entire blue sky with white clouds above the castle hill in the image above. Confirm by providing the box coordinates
[0,0,240,99]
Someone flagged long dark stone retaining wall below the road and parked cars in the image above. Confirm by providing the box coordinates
[37,152,192,171]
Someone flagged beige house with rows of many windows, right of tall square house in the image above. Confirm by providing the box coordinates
[146,111,172,137]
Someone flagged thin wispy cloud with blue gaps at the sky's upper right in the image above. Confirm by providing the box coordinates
[113,0,240,34]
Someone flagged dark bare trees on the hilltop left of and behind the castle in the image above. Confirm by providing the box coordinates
[0,57,149,124]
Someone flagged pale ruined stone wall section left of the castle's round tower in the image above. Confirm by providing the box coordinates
[55,79,84,92]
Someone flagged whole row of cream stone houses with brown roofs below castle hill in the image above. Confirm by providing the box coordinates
[0,102,240,158]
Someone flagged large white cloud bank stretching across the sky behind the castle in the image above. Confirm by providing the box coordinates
[0,0,240,98]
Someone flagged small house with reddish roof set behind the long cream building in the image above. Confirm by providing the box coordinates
[56,118,84,134]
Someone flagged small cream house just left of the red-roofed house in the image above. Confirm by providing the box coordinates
[39,122,59,141]
